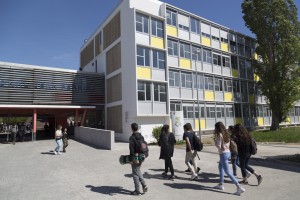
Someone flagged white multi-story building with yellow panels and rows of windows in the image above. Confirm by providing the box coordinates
[80,0,300,141]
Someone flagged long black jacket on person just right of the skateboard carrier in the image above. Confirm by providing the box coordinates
[158,133,176,159]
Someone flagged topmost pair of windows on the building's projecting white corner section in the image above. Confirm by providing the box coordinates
[136,13,164,38]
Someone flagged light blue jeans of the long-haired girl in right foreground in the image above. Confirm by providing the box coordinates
[219,152,239,185]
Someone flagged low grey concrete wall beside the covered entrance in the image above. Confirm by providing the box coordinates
[75,127,115,150]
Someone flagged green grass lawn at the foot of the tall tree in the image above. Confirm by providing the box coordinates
[251,127,300,143]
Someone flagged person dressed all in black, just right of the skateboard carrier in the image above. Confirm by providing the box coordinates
[158,124,176,180]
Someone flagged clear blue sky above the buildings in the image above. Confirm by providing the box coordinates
[0,0,300,69]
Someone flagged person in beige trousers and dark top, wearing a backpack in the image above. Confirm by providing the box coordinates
[183,123,198,181]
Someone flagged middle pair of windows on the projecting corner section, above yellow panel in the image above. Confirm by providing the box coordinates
[136,46,166,69]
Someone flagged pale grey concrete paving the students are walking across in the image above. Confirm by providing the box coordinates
[0,140,300,200]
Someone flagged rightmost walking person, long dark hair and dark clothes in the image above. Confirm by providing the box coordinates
[233,124,262,185]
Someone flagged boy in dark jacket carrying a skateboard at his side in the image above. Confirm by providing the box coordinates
[129,123,148,195]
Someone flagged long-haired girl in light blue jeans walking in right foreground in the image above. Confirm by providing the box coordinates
[214,122,246,195]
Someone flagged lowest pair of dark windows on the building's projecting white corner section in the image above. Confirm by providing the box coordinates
[138,81,167,102]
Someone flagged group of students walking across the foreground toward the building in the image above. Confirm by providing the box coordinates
[129,122,262,195]
